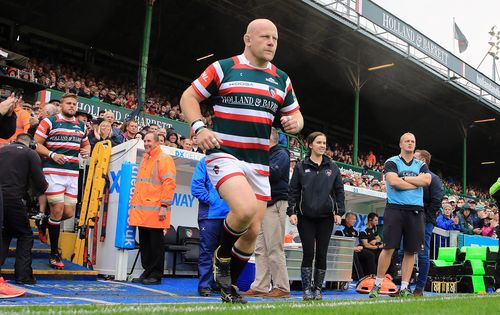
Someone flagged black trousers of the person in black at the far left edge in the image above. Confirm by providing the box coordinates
[0,199,33,280]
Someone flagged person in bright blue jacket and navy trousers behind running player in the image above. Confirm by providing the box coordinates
[191,158,229,296]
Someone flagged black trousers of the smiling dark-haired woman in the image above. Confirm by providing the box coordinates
[297,215,334,270]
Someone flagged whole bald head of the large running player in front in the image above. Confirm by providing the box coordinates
[243,19,278,68]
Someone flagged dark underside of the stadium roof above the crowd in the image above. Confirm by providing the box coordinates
[0,0,500,186]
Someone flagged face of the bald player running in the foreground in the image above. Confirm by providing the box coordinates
[247,23,278,62]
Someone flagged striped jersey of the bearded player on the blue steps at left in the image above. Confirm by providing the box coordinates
[36,114,89,176]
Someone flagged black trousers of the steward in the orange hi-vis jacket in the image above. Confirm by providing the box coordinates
[139,226,165,279]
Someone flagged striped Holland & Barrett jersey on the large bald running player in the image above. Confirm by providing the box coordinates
[191,54,300,175]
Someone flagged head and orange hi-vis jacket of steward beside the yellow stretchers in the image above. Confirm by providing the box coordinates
[129,134,176,229]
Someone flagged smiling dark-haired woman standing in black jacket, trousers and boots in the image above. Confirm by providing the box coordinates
[287,132,345,300]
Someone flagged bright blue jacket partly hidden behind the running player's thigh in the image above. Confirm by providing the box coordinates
[191,158,229,220]
